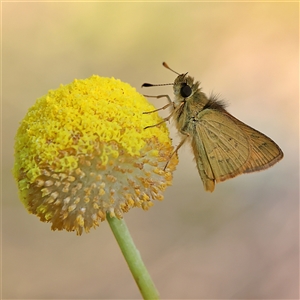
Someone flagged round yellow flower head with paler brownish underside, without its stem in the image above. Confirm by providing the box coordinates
[13,75,178,235]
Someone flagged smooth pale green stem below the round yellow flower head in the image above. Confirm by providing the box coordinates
[107,214,159,299]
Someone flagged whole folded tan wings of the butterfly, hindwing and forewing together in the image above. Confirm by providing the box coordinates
[192,109,283,192]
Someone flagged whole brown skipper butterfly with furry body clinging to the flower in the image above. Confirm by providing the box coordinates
[142,62,283,192]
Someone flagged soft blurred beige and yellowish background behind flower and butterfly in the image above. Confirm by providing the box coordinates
[2,2,299,299]
